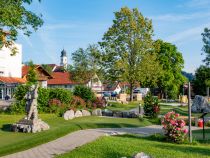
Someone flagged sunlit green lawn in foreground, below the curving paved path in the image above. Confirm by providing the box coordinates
[57,135,210,158]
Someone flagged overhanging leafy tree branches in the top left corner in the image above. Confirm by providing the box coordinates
[0,0,43,55]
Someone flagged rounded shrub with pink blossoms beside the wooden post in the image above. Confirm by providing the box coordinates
[162,111,188,143]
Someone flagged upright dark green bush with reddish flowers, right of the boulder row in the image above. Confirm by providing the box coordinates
[144,93,160,118]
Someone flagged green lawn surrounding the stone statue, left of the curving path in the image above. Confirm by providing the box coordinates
[0,114,151,156]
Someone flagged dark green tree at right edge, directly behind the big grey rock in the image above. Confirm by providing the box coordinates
[193,65,210,95]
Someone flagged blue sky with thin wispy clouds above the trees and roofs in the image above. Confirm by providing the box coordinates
[17,0,210,73]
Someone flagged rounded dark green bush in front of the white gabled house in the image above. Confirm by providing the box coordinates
[73,86,95,102]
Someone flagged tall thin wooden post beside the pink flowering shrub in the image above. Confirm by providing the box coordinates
[188,82,192,143]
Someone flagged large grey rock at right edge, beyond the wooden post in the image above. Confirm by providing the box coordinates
[191,95,210,113]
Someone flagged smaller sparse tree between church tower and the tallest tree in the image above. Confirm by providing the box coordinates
[69,45,102,82]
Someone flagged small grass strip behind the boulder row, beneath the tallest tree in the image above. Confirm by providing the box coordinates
[106,101,140,111]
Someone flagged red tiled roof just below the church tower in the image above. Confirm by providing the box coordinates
[47,72,78,85]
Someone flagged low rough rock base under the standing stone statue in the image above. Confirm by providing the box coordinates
[11,118,50,133]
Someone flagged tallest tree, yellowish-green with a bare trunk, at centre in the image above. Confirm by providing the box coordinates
[99,7,153,100]
